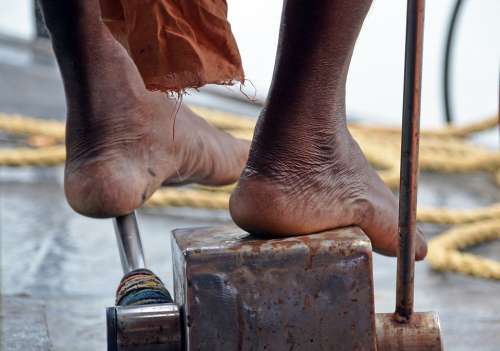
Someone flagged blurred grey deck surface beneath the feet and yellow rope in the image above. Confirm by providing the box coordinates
[0,40,500,351]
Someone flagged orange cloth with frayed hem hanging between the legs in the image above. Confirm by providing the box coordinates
[100,0,244,92]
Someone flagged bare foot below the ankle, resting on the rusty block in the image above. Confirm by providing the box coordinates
[230,133,427,259]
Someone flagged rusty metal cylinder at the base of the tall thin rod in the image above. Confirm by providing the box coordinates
[376,312,443,351]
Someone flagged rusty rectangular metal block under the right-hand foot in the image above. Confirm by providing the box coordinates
[172,226,375,351]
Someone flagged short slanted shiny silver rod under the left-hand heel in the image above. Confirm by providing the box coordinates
[113,212,146,274]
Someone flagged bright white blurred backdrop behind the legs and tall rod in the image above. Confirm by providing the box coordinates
[0,0,500,126]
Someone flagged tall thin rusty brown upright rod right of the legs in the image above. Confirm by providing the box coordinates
[396,0,425,321]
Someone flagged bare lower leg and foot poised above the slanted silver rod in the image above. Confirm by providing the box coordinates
[41,0,249,217]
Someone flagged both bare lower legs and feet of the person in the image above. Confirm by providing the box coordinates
[40,0,427,259]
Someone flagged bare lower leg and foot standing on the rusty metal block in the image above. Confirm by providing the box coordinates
[230,0,426,259]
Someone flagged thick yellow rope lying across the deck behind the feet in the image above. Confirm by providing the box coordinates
[0,107,500,279]
